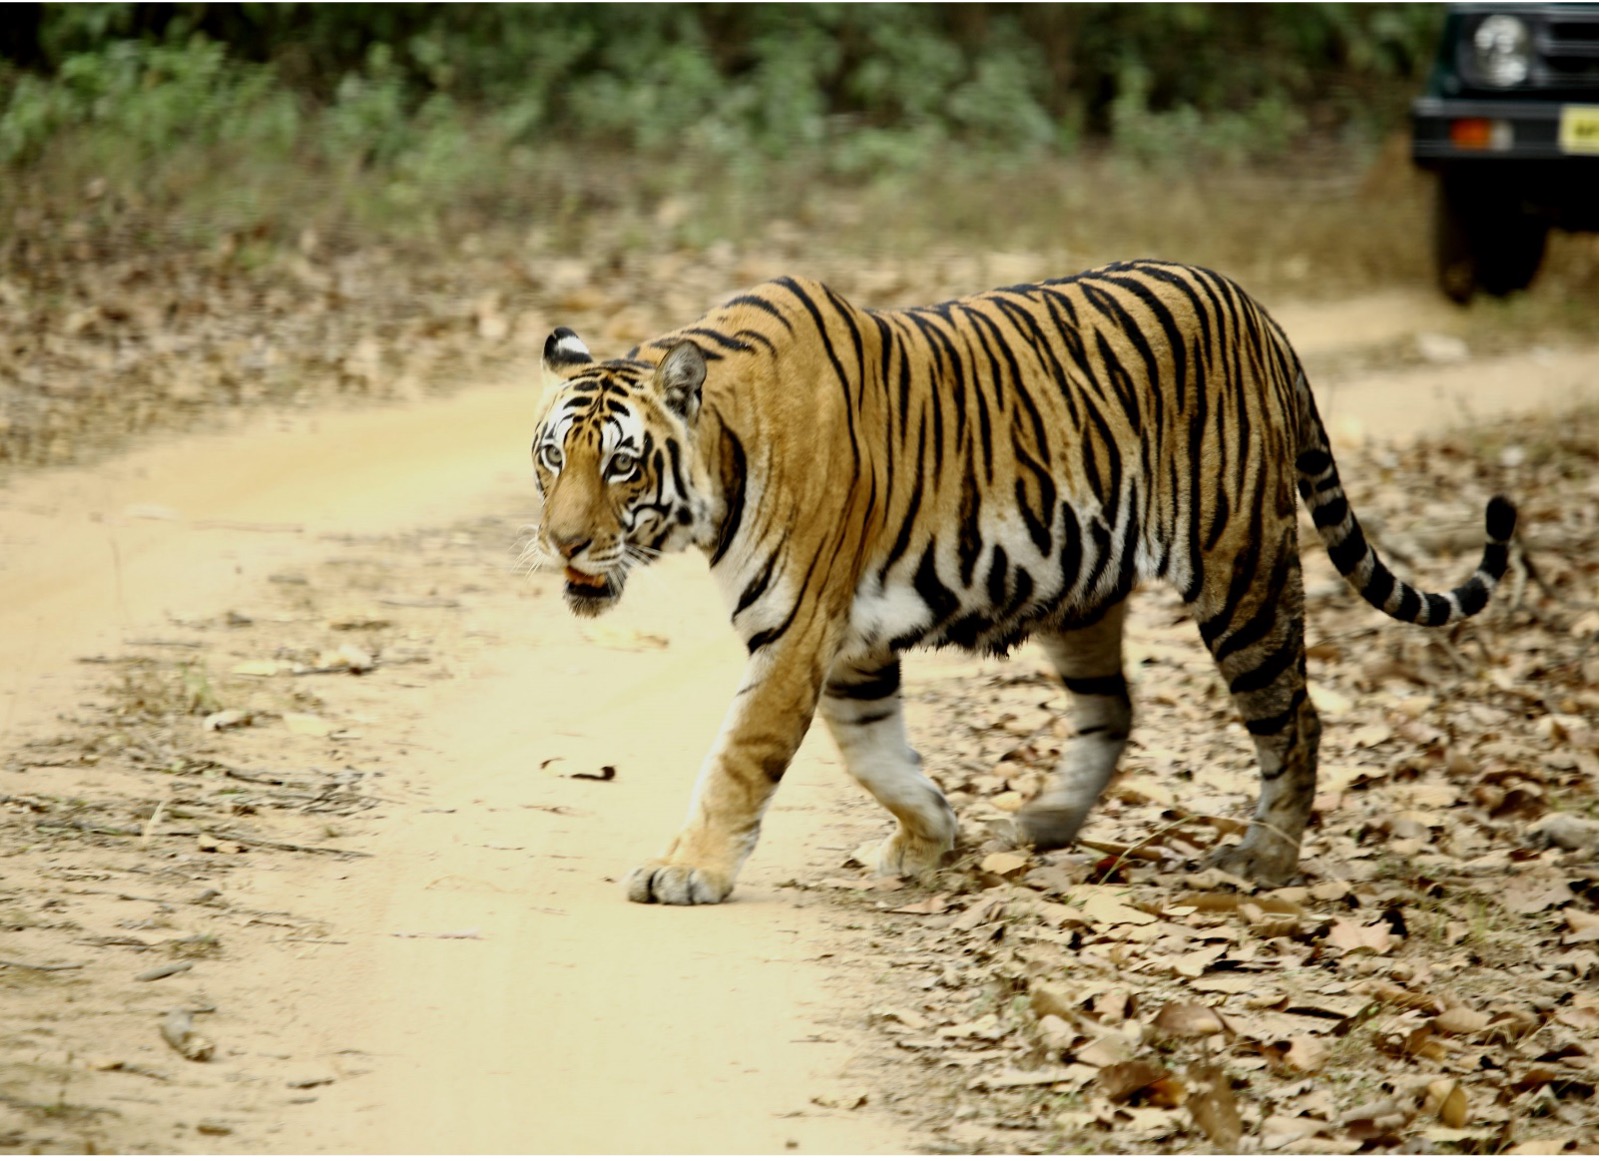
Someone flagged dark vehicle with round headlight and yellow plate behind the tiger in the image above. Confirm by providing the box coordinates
[1413,3,1599,301]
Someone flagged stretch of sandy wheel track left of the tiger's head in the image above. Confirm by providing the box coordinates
[0,388,533,726]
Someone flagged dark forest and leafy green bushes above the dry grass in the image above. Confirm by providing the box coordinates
[0,3,1440,167]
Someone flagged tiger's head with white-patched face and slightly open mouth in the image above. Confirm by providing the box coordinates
[525,327,712,617]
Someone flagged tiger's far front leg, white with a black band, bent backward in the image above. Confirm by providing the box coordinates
[820,657,958,877]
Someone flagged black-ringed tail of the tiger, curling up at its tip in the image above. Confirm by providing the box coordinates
[1296,367,1516,625]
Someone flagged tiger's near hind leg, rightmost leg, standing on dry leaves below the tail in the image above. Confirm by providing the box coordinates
[1192,524,1320,885]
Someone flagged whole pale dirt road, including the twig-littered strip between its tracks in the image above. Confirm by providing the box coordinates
[0,285,1599,1153]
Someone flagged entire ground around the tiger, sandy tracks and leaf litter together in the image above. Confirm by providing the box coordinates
[0,169,1599,1153]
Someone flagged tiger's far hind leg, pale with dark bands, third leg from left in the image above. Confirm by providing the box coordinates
[1017,601,1131,850]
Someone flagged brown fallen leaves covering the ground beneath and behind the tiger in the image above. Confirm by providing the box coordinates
[804,405,1598,1153]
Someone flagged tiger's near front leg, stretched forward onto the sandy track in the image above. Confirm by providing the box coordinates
[629,635,823,904]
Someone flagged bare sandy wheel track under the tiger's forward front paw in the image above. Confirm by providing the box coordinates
[272,561,905,1153]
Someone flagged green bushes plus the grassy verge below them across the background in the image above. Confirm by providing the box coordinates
[0,3,1440,248]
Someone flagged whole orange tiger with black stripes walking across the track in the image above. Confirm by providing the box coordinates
[531,260,1516,904]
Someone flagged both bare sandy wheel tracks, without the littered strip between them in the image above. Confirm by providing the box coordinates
[0,288,1598,1153]
